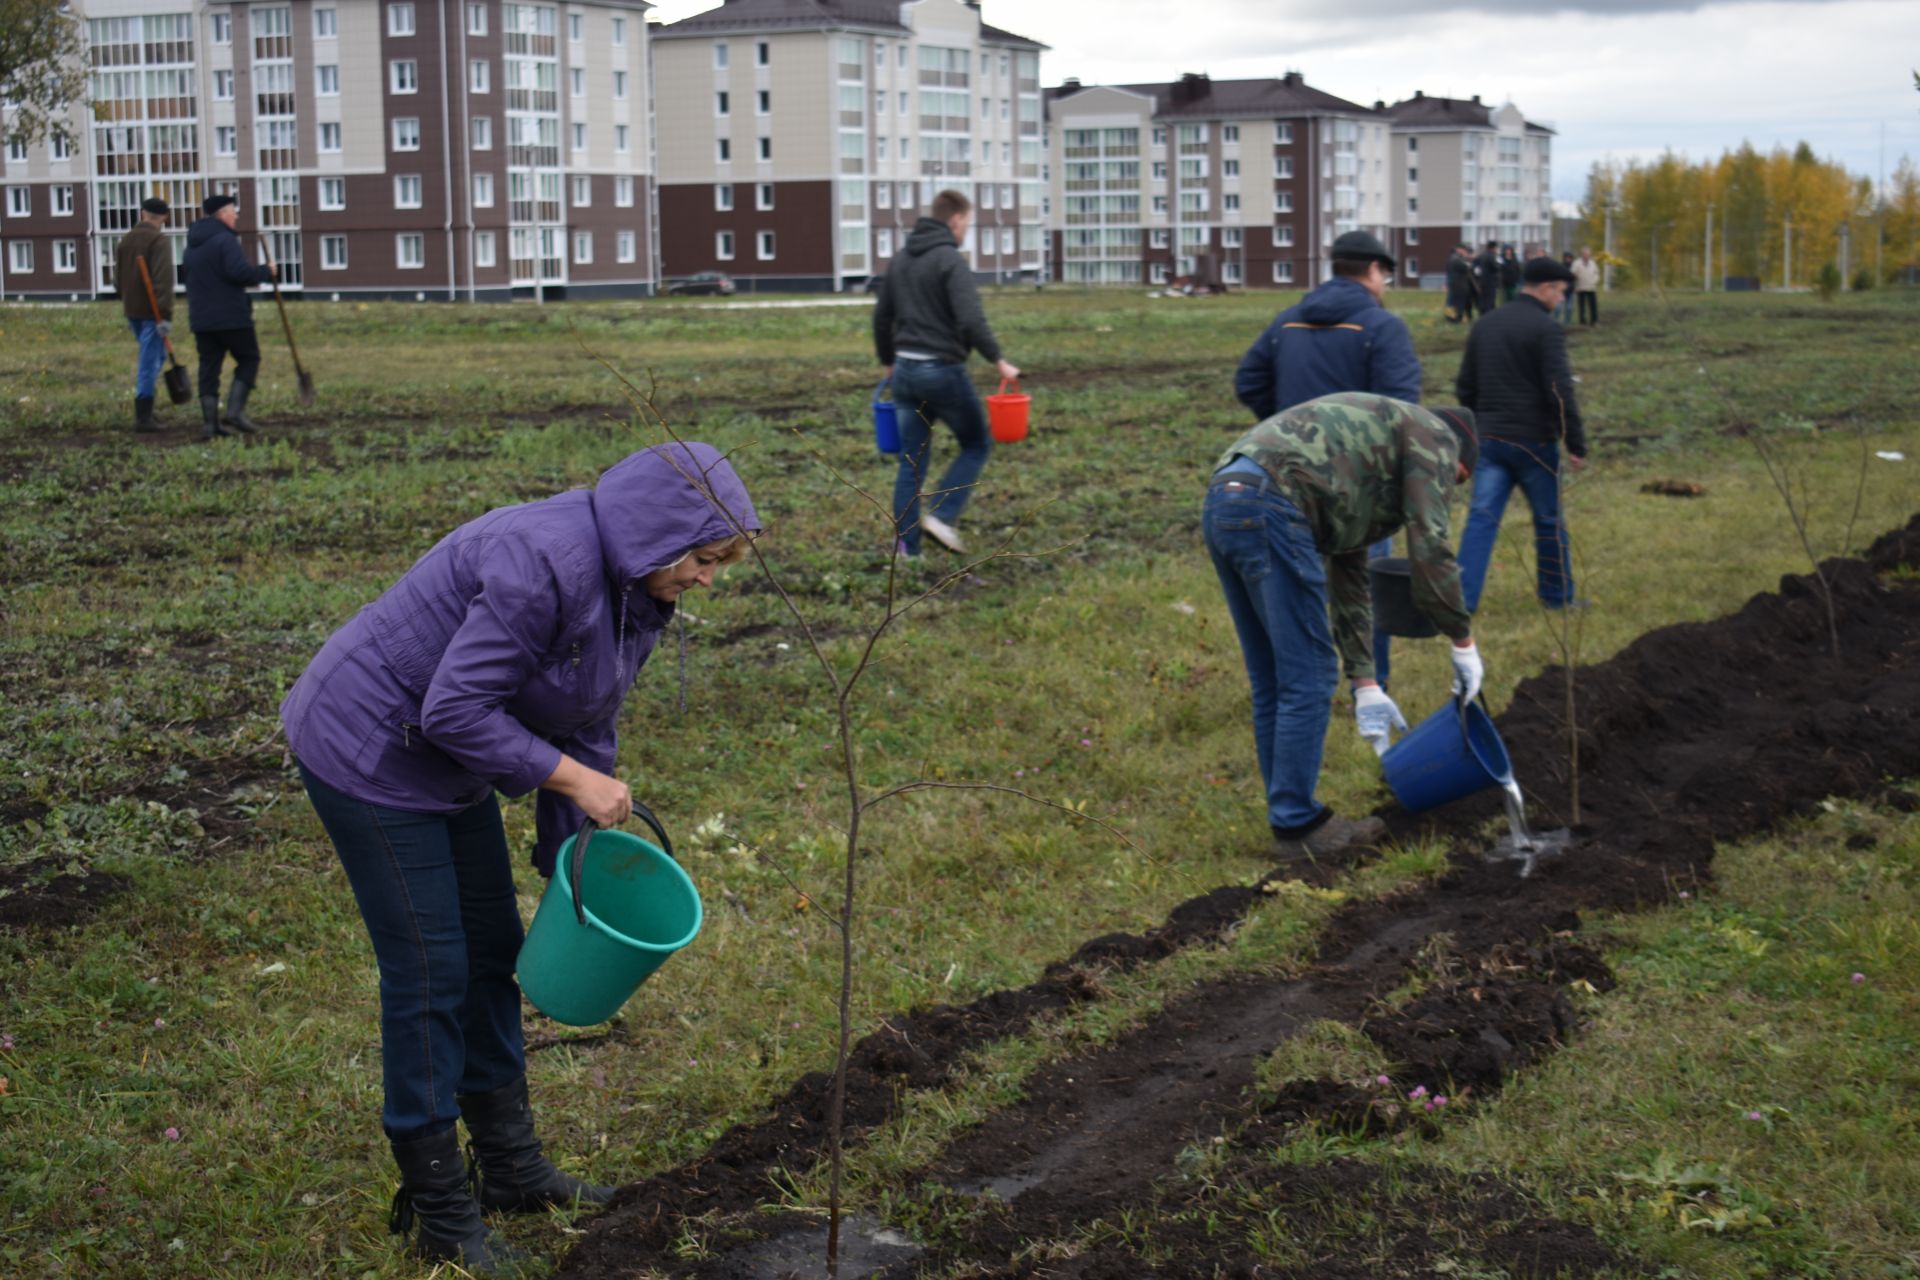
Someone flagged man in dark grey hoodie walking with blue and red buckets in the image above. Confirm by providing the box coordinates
[874,190,1020,557]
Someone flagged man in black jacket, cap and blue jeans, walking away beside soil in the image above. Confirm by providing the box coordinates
[1453,257,1586,612]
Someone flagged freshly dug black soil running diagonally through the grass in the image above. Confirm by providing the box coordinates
[559,518,1920,1278]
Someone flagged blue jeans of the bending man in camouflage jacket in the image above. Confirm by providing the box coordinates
[1200,474,1340,837]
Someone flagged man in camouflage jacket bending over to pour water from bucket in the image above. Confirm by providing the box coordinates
[1202,391,1482,858]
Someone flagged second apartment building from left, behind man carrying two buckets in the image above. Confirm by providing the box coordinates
[653,0,1044,290]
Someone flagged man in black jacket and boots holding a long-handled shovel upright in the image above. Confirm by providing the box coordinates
[180,196,278,439]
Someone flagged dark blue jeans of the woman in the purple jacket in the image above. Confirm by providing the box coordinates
[300,766,526,1138]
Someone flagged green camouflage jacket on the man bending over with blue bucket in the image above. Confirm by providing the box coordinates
[1215,391,1469,679]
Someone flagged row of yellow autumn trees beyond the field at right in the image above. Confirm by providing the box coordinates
[1582,142,1920,288]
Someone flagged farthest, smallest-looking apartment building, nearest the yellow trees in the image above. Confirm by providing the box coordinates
[1377,92,1553,285]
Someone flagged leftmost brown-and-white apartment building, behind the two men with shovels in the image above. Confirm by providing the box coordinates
[0,0,659,297]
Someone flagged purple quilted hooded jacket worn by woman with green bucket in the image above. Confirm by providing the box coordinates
[280,443,760,875]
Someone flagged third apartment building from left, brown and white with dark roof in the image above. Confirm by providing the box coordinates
[1048,71,1390,286]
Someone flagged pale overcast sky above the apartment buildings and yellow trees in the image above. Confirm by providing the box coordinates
[653,0,1920,200]
